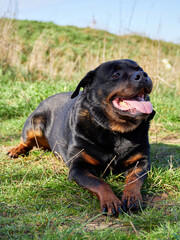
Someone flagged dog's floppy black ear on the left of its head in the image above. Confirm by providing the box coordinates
[71,70,96,98]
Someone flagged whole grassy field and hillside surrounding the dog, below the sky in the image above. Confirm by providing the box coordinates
[0,19,180,240]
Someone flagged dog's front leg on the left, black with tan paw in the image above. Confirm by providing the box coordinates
[69,152,122,215]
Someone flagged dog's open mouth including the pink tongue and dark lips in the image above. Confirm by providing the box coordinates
[112,91,153,115]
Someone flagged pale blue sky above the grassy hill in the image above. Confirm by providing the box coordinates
[0,0,180,43]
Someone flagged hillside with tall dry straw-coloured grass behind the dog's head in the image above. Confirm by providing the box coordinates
[0,19,180,84]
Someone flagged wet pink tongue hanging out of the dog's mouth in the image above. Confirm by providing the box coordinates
[113,97,153,114]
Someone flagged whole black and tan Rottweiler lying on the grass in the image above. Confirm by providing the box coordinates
[8,60,155,215]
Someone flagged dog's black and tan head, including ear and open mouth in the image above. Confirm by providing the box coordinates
[72,59,154,133]
